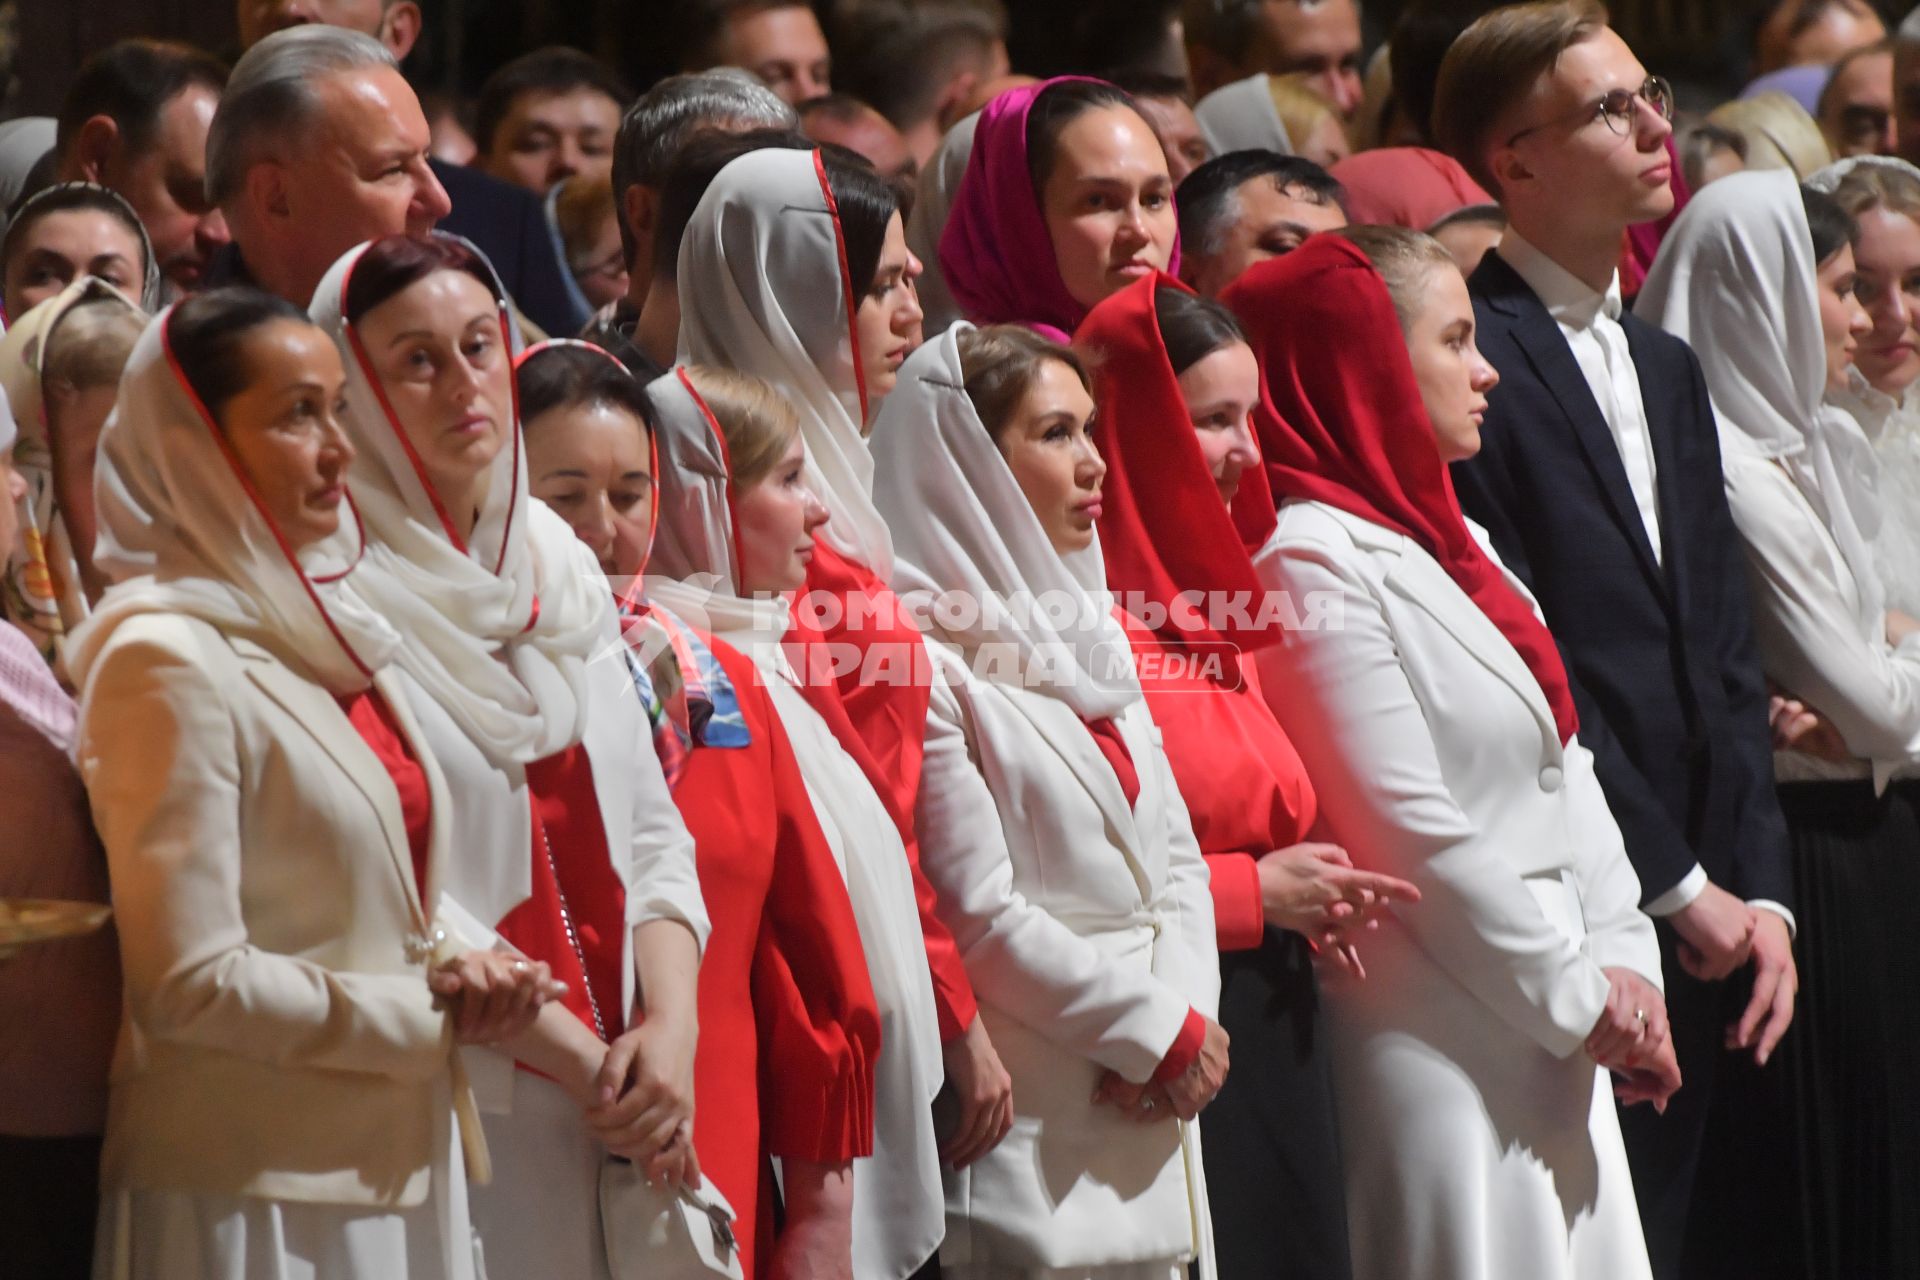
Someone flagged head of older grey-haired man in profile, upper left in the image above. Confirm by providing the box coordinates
[207,25,451,307]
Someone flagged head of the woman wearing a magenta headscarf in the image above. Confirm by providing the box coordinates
[941,77,1179,342]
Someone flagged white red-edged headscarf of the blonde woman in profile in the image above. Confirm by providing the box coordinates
[647,368,791,666]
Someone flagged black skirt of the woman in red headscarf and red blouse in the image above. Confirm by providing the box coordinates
[1200,929,1354,1280]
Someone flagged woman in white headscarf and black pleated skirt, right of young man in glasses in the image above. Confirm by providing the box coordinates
[1636,173,1920,1276]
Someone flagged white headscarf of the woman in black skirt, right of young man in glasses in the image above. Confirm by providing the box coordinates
[1634,169,1885,635]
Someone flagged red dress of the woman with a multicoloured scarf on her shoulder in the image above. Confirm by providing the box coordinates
[656,635,879,1276]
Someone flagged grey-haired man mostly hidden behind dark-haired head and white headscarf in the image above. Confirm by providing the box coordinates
[586,67,801,376]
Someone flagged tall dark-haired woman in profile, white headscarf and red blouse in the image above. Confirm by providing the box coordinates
[680,150,1012,1220]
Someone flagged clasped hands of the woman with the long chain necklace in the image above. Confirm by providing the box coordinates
[588,1015,701,1186]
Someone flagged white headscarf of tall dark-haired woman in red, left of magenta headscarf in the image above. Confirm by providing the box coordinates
[678,148,893,580]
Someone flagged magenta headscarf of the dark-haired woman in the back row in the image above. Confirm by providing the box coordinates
[941,75,1181,342]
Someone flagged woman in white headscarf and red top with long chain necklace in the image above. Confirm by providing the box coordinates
[311,236,707,1276]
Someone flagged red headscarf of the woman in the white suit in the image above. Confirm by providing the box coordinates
[1221,236,1578,743]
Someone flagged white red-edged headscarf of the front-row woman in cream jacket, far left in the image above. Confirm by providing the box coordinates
[67,307,399,695]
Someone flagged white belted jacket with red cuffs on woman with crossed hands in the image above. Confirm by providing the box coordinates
[918,643,1219,1268]
